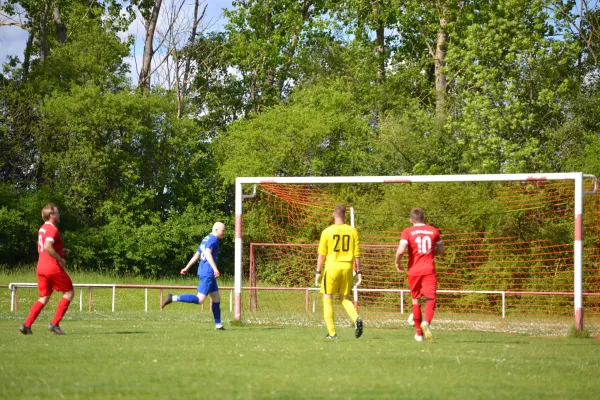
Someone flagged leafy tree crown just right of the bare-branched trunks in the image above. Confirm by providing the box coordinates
[193,0,322,121]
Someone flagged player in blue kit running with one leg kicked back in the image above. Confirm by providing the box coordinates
[160,222,225,331]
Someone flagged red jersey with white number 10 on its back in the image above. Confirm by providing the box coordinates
[400,224,442,276]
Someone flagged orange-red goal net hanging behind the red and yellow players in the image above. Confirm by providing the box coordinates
[236,175,600,329]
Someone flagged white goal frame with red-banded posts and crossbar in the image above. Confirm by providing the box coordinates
[234,172,598,331]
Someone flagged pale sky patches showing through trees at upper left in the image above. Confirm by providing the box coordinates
[0,0,233,77]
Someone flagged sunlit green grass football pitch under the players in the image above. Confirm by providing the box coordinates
[0,268,600,399]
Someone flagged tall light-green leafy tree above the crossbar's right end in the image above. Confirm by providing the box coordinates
[447,0,581,173]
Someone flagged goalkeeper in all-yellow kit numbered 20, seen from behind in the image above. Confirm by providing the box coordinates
[315,205,363,339]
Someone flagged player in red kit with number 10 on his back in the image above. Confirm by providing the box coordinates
[396,208,444,342]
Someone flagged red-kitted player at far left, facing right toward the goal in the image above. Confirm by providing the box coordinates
[19,204,74,335]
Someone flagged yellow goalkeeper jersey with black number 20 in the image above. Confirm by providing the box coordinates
[318,224,360,269]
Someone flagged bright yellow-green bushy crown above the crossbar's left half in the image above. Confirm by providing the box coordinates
[216,81,372,182]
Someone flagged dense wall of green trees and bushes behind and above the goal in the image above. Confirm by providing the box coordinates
[0,0,600,275]
